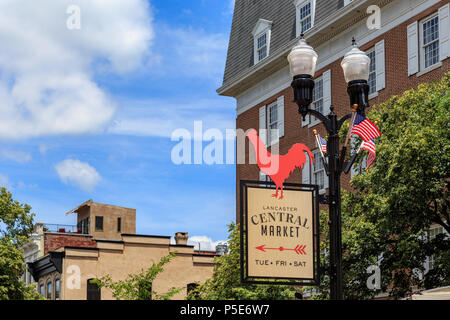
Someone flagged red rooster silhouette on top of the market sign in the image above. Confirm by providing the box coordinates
[247,129,315,199]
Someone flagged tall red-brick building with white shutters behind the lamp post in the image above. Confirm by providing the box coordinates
[217,0,450,220]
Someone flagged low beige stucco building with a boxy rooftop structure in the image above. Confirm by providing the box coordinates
[29,201,214,300]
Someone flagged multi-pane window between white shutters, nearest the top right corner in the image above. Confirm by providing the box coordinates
[422,16,439,68]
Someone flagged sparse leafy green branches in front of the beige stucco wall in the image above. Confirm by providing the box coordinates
[91,252,182,300]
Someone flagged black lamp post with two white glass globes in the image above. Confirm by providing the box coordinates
[288,35,370,300]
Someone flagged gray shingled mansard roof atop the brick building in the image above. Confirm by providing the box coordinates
[223,0,344,85]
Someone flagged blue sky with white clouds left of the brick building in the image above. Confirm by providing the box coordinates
[0,0,235,249]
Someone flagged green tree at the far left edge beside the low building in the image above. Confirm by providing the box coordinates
[0,188,40,300]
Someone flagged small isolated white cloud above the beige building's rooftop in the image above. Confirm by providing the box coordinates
[55,159,101,191]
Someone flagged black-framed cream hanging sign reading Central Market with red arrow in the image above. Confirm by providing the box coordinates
[240,181,319,285]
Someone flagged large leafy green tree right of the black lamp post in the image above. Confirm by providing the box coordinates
[312,73,450,299]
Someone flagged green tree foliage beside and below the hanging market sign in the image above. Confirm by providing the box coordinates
[188,223,295,300]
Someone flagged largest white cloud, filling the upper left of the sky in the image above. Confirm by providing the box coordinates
[0,0,153,138]
